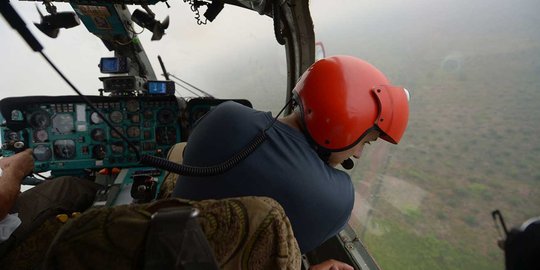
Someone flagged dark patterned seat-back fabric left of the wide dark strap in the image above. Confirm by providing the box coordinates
[45,205,151,270]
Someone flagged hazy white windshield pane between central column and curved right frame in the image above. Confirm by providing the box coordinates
[141,5,287,112]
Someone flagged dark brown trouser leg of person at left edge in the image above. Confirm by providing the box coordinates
[0,176,99,269]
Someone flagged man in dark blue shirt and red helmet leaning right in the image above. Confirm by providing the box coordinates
[173,56,408,258]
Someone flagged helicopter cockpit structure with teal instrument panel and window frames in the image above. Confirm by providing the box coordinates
[0,1,376,269]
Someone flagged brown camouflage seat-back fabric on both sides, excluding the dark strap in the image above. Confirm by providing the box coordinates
[3,197,300,270]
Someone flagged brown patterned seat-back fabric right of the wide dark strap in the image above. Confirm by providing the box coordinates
[190,197,301,270]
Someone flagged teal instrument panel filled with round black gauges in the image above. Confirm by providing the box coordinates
[0,96,182,172]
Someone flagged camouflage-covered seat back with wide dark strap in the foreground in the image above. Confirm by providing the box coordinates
[3,143,301,270]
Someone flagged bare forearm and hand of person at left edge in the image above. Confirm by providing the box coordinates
[0,149,34,220]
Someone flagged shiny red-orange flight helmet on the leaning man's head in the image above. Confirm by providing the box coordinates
[293,55,409,152]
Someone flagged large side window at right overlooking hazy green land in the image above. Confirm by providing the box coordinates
[311,0,540,270]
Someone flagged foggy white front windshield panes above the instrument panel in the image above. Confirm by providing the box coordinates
[0,1,287,112]
